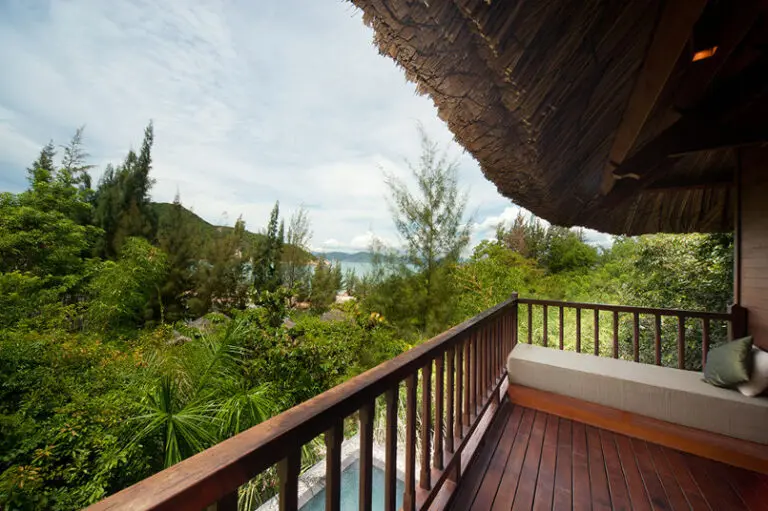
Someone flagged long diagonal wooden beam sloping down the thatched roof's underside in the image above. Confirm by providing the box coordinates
[601,0,707,194]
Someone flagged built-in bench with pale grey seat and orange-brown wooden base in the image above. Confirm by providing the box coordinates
[507,344,768,472]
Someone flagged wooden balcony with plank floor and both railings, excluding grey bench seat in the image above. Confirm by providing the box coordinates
[90,295,768,511]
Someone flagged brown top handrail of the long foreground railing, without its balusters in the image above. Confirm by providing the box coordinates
[88,296,522,511]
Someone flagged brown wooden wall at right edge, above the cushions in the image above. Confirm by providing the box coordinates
[738,147,768,349]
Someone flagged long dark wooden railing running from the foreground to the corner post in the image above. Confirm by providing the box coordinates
[90,295,517,511]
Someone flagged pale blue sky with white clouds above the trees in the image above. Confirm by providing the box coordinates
[0,0,610,251]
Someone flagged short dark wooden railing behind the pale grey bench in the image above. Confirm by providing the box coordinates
[518,298,746,369]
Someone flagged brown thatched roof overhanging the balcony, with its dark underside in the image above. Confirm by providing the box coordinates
[353,0,768,234]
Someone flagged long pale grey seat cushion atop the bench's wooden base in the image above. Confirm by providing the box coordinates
[507,344,768,445]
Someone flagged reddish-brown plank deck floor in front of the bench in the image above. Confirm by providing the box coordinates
[451,400,768,511]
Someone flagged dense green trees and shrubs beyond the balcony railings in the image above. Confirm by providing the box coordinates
[0,125,732,509]
